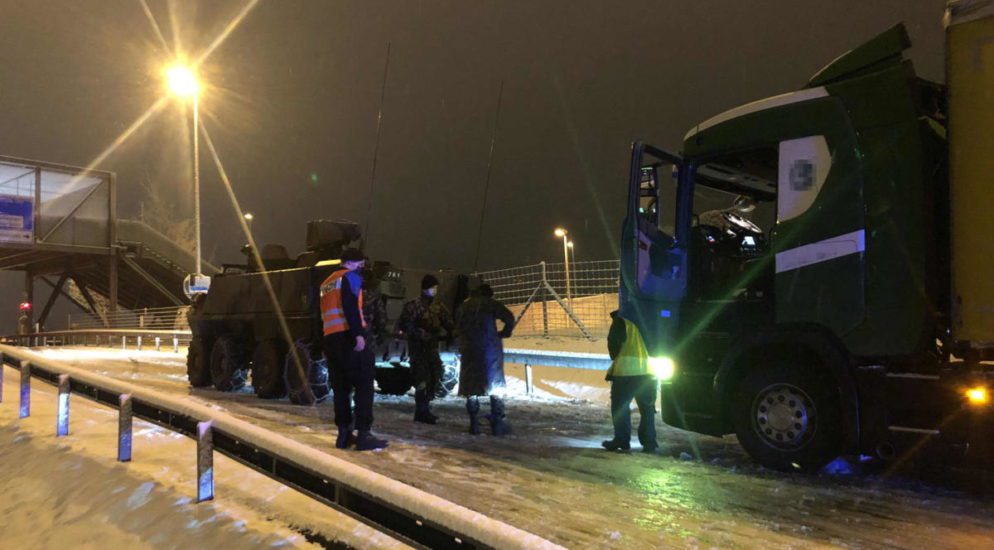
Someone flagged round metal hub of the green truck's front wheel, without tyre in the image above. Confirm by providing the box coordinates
[752,384,816,449]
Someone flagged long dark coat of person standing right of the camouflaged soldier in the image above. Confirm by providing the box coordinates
[456,296,514,397]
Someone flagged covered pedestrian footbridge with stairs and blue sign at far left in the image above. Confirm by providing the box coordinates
[0,156,218,328]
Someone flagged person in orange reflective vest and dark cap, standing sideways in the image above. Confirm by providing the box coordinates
[320,248,387,451]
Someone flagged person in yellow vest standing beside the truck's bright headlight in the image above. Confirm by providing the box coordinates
[601,311,659,453]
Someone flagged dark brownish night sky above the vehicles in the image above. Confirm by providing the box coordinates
[0,0,945,324]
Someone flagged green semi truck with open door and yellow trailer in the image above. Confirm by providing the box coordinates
[619,7,994,470]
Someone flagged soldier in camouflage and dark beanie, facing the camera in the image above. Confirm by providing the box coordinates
[397,275,454,424]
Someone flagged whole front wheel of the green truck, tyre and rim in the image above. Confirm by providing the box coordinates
[731,362,843,471]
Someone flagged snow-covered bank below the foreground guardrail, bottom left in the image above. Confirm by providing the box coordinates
[0,360,407,549]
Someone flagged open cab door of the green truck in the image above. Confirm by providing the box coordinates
[619,142,687,356]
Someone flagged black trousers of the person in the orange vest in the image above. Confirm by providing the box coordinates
[324,332,376,432]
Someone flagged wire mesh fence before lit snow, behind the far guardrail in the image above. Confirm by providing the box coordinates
[476,260,620,340]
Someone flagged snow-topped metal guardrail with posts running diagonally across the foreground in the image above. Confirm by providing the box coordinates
[0,345,560,548]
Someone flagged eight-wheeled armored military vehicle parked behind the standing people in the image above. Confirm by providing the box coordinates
[187,220,467,404]
